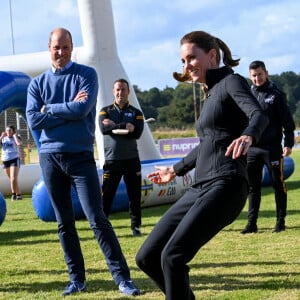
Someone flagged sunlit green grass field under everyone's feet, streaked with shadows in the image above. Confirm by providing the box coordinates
[0,151,300,300]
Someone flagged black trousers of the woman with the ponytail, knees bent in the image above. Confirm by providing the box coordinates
[136,177,248,300]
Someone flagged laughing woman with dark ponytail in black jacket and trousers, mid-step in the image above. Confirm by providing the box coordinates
[136,31,268,300]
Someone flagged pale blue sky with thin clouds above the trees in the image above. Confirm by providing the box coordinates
[0,0,300,90]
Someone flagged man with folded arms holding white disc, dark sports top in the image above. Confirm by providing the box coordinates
[99,79,144,236]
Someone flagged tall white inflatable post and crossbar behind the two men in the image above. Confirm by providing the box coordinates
[0,0,160,166]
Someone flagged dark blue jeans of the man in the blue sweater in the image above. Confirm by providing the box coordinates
[40,152,130,284]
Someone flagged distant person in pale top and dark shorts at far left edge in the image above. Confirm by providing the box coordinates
[0,125,22,201]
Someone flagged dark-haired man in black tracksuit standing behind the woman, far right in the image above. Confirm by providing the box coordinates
[241,61,295,234]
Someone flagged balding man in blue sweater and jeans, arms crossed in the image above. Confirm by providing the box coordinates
[26,28,140,296]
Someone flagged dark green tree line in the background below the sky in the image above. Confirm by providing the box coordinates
[133,71,300,129]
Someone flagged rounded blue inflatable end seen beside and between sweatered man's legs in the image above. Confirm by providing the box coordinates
[32,178,85,222]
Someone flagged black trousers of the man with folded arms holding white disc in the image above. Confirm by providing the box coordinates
[102,158,142,229]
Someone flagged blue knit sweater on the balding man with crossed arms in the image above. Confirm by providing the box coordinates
[26,63,98,153]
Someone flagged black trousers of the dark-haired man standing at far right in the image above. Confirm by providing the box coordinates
[247,147,287,225]
